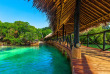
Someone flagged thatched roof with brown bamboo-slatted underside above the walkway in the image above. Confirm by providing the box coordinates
[29,0,110,35]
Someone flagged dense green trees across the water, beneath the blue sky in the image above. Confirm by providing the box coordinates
[0,21,52,45]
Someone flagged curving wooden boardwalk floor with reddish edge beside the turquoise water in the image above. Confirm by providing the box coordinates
[46,42,110,74]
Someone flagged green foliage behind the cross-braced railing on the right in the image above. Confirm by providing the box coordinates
[80,26,110,44]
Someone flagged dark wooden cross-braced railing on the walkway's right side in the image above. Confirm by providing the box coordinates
[80,30,110,51]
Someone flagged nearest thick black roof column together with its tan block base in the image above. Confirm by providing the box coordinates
[72,0,81,59]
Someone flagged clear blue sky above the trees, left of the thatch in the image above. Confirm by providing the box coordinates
[0,0,49,28]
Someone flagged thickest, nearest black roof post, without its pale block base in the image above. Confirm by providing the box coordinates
[74,0,81,48]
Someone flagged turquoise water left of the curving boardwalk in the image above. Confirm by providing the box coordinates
[0,45,71,74]
